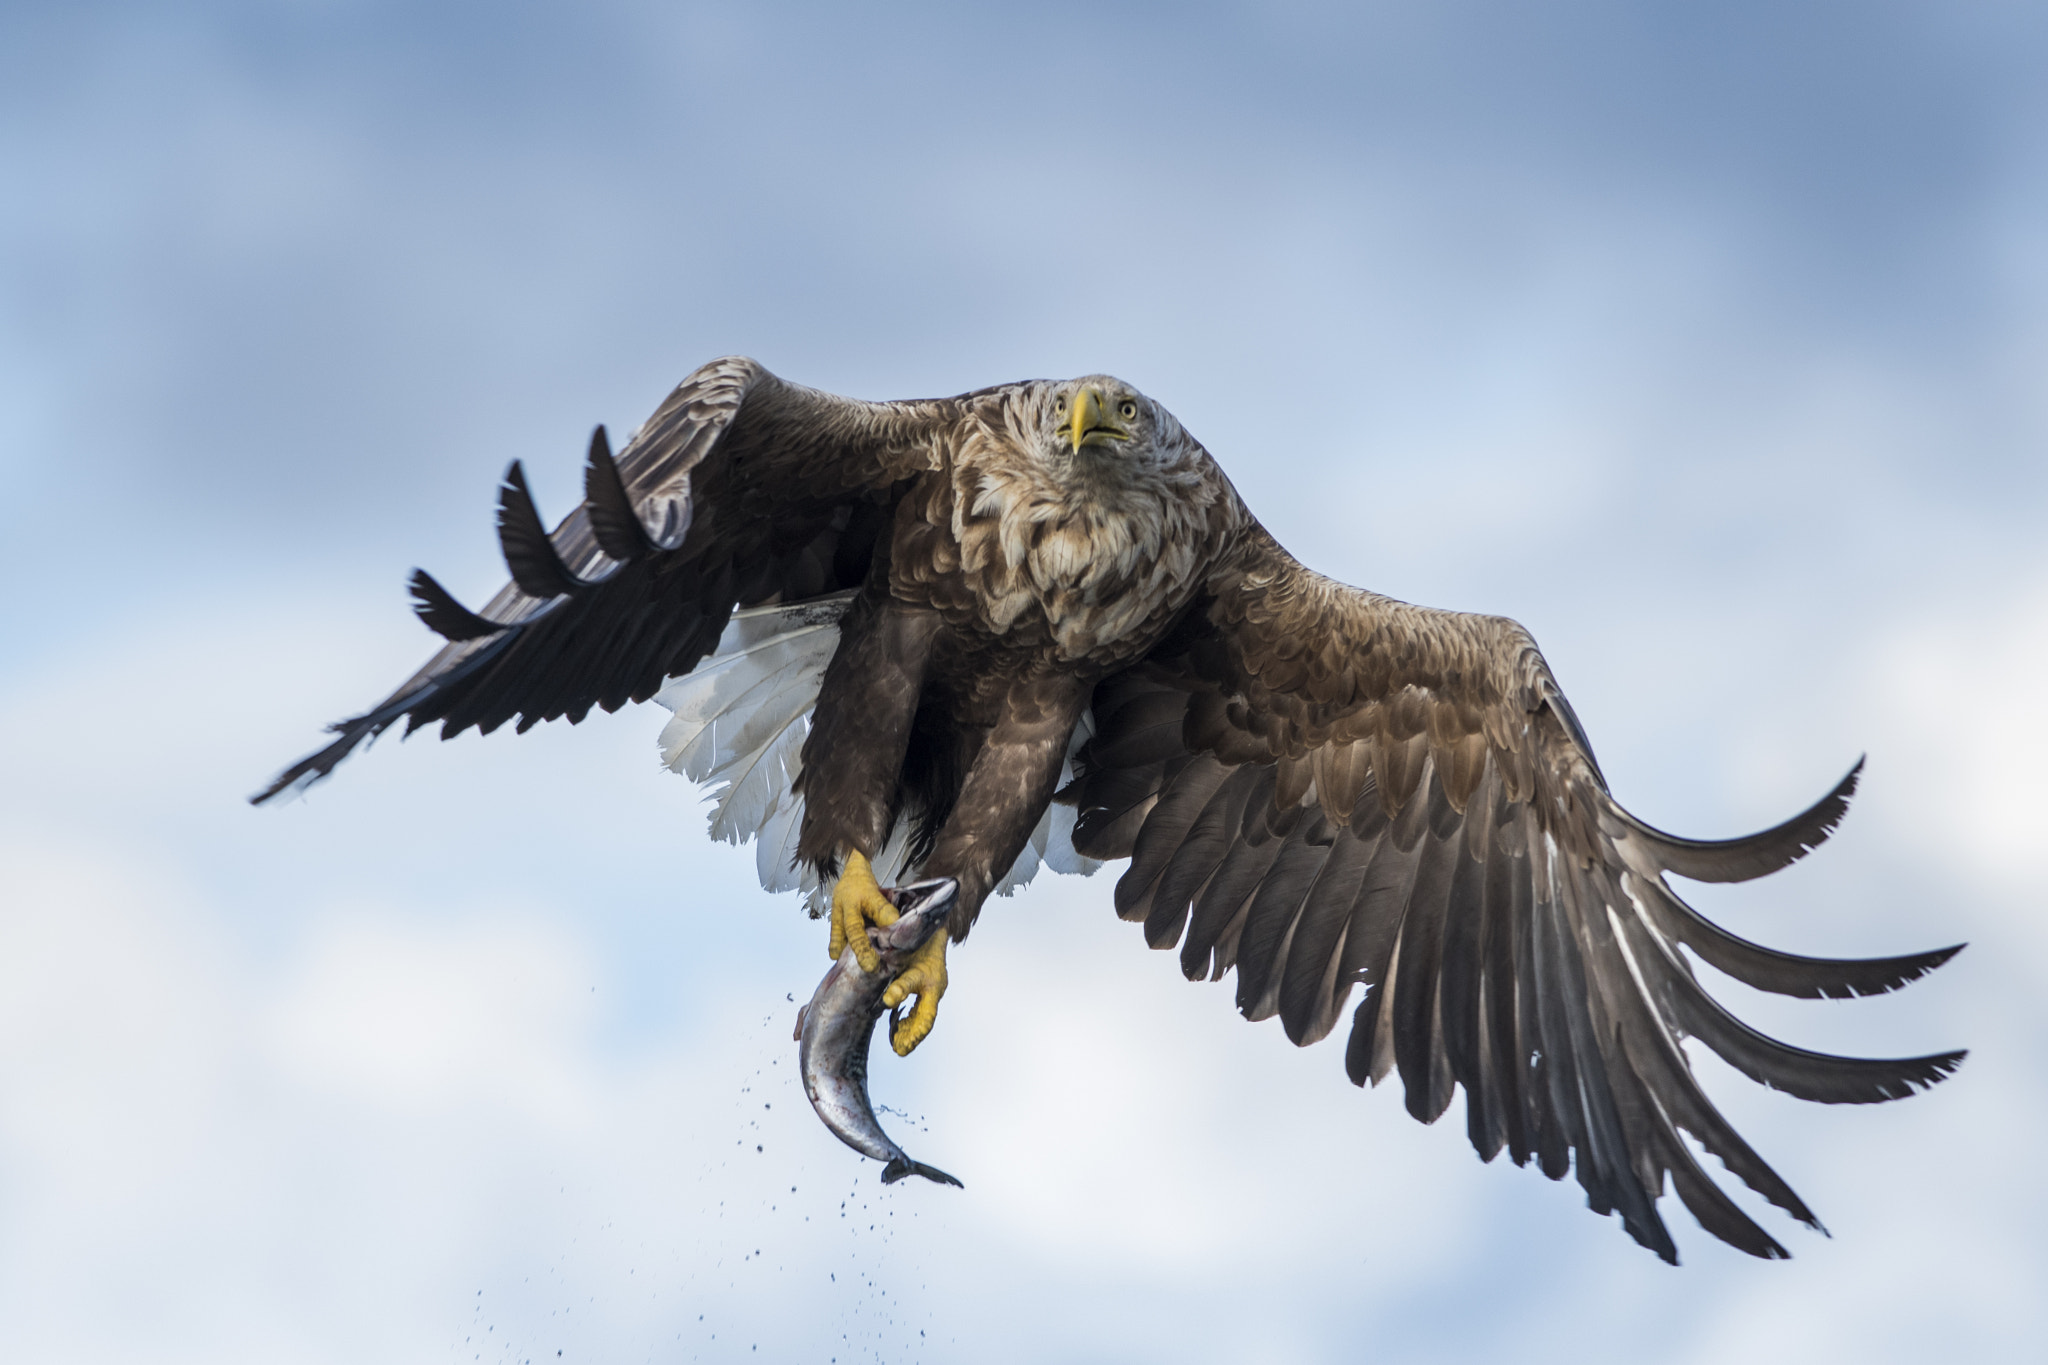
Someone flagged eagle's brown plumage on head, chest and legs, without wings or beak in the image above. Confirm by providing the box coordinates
[799,377,1245,939]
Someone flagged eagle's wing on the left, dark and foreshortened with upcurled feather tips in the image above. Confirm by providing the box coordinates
[250,358,958,802]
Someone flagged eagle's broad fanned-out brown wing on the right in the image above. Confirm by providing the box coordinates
[1065,526,1962,1261]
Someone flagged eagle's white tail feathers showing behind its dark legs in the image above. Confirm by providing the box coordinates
[655,593,1102,917]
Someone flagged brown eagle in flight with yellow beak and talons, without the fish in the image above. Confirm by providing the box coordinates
[252,358,1964,1263]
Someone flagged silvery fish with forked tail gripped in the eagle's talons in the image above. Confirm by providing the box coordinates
[795,876,961,1185]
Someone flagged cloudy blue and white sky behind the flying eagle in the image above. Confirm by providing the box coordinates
[0,0,2048,1363]
